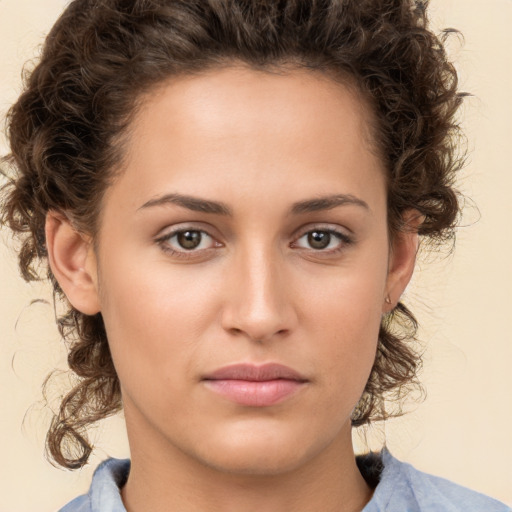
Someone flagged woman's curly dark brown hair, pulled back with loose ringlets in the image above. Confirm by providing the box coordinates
[0,0,464,468]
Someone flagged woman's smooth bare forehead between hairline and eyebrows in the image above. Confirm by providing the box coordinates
[104,67,383,216]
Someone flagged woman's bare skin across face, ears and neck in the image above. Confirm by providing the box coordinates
[46,67,417,512]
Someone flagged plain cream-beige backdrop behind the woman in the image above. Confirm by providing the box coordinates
[0,0,512,512]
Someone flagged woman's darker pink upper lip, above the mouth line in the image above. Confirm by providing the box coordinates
[204,363,307,382]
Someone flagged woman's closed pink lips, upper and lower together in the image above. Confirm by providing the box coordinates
[203,363,307,407]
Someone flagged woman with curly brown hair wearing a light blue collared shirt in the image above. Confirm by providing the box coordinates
[3,0,509,512]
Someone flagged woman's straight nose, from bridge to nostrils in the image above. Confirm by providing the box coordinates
[222,244,297,342]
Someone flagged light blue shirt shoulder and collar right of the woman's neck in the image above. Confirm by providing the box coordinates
[364,450,512,512]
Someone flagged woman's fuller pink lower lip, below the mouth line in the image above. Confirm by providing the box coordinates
[204,379,305,407]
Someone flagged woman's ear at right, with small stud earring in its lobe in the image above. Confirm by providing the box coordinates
[383,209,425,313]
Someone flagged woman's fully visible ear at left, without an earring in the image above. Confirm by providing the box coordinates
[45,211,100,315]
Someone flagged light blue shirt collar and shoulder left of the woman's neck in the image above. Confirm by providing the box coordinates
[59,459,130,512]
